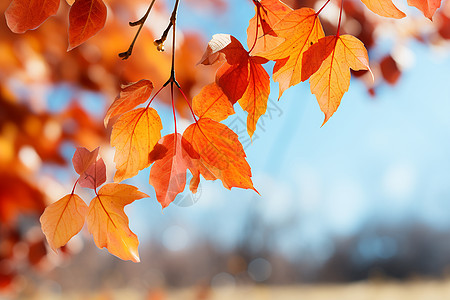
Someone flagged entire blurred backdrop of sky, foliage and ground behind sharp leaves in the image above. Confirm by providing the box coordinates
[0,0,450,299]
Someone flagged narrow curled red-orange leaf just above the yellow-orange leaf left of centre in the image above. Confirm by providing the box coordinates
[104,79,153,127]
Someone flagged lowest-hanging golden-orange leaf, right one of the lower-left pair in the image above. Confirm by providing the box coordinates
[86,183,148,262]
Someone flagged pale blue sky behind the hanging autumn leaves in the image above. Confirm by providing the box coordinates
[48,0,450,260]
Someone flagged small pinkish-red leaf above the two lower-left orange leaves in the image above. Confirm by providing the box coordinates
[72,147,106,189]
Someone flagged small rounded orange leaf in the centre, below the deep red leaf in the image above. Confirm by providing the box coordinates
[192,83,234,122]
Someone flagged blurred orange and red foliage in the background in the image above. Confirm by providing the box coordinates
[0,0,450,299]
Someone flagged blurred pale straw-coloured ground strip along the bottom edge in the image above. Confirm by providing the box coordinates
[7,279,450,300]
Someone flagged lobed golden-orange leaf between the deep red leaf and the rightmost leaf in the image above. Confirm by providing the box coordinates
[260,8,324,97]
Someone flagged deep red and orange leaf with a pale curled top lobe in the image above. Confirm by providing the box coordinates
[201,34,270,137]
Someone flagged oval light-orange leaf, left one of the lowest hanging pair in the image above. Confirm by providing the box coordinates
[40,194,88,252]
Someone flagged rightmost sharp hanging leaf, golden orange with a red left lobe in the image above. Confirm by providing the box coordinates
[302,35,373,126]
